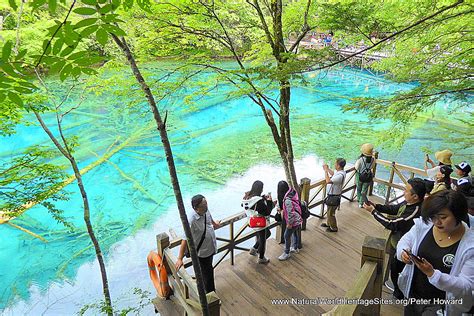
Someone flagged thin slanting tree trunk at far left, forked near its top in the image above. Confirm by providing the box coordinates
[34,112,113,316]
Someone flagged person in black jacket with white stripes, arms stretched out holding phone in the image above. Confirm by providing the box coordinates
[363,178,426,299]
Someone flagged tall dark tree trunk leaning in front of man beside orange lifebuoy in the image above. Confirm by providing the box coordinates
[111,34,209,315]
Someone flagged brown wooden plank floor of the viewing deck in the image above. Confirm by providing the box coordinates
[156,197,403,315]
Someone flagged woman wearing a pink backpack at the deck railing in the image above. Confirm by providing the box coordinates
[278,181,303,261]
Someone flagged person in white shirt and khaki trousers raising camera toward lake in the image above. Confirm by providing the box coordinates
[321,158,346,233]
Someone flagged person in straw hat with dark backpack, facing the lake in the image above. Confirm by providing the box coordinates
[354,143,375,207]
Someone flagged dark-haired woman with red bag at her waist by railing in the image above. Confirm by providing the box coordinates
[242,180,273,264]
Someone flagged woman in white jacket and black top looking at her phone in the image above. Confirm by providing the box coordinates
[397,191,474,315]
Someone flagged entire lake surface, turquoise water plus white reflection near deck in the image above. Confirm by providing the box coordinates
[0,65,468,315]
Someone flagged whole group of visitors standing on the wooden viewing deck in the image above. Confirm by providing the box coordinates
[176,144,474,315]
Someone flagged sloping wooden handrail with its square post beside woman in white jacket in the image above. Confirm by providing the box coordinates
[323,231,390,316]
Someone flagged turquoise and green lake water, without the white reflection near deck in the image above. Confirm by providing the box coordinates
[0,65,468,310]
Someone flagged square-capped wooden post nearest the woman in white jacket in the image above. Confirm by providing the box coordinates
[361,236,386,315]
